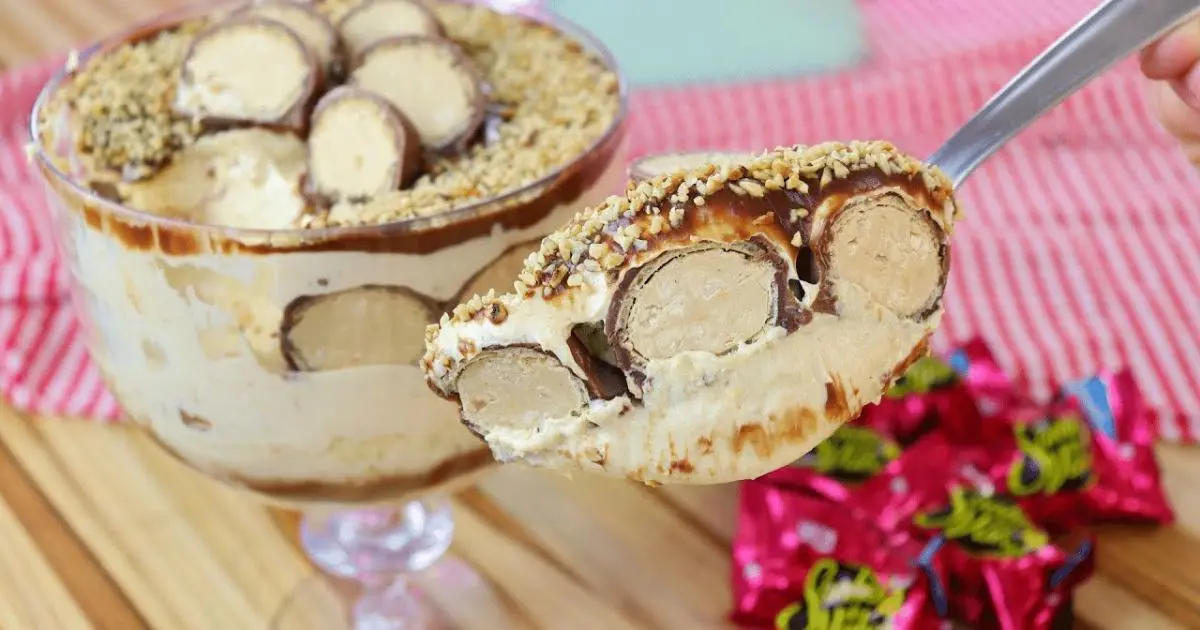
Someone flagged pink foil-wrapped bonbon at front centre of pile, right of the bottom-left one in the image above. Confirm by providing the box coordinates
[860,434,1094,630]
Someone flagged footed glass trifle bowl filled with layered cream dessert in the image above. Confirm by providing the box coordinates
[31,0,628,629]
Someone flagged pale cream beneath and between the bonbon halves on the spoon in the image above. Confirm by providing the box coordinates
[433,278,926,484]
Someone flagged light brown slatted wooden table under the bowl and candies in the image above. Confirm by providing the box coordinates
[0,0,1200,630]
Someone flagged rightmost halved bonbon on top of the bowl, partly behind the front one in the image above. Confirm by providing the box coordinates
[350,36,486,151]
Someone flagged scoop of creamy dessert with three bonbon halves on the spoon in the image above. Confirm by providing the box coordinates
[421,142,959,484]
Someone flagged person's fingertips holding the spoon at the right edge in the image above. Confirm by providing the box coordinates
[1140,18,1200,166]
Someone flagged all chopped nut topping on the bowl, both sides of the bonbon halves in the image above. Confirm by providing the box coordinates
[42,0,620,228]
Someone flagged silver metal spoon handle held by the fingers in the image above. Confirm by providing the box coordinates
[929,0,1200,187]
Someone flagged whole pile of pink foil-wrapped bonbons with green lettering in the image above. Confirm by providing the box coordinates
[733,341,1174,630]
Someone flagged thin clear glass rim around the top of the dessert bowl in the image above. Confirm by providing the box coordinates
[28,0,630,242]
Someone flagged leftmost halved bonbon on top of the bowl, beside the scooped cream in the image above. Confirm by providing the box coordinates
[175,17,323,132]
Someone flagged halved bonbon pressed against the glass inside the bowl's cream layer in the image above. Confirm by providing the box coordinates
[280,284,437,372]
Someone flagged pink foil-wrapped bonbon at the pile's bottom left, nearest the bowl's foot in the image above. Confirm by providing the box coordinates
[731,481,949,630]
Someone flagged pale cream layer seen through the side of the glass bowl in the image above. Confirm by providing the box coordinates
[55,152,624,503]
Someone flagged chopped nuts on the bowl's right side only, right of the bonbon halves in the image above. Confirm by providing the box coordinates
[331,2,620,224]
